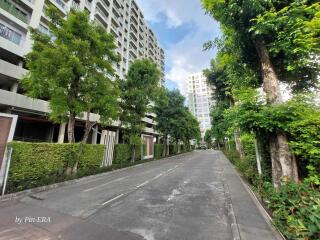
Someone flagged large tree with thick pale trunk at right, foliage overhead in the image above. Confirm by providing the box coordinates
[202,0,320,186]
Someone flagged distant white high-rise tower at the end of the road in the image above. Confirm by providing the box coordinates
[187,72,214,139]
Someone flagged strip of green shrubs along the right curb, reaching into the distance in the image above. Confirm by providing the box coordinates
[225,135,320,240]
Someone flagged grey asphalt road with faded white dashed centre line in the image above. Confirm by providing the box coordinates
[0,150,277,240]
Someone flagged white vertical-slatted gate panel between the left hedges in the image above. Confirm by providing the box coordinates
[100,130,116,167]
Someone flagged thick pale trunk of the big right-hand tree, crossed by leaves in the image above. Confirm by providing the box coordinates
[255,40,298,187]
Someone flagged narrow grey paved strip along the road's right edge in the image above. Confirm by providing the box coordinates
[217,153,283,240]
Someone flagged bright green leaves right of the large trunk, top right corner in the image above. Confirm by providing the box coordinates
[250,1,320,91]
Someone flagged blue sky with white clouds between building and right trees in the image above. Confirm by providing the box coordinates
[137,0,219,93]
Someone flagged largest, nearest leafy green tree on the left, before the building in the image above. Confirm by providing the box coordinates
[22,7,119,174]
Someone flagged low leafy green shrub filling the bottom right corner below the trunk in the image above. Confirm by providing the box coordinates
[260,182,320,240]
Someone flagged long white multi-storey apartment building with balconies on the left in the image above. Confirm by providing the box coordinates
[0,0,164,143]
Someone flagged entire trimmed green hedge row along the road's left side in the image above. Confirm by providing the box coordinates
[7,142,194,193]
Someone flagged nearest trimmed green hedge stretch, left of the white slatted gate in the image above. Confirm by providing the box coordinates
[7,142,104,192]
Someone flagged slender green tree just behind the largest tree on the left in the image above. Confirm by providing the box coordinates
[118,59,161,162]
